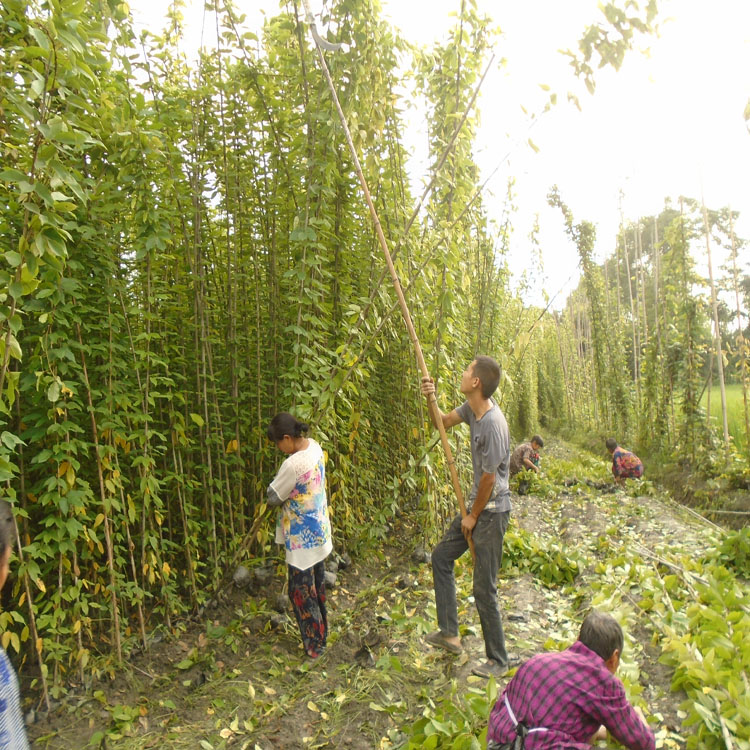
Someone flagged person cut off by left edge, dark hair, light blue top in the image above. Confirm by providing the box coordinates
[0,499,29,750]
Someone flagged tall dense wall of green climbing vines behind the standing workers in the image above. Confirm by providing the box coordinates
[0,0,523,687]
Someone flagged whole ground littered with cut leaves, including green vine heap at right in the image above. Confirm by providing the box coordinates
[31,440,748,750]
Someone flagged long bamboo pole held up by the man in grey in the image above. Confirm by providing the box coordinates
[303,0,476,559]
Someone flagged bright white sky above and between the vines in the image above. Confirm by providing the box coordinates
[130,0,750,307]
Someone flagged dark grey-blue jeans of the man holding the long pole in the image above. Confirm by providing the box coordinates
[432,510,510,667]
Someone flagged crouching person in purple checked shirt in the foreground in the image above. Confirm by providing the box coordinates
[487,610,656,750]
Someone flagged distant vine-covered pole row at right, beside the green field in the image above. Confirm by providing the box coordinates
[550,190,750,464]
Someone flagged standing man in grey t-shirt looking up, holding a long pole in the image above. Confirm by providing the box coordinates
[422,356,511,677]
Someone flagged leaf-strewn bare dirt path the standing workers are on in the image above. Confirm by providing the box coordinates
[30,438,706,750]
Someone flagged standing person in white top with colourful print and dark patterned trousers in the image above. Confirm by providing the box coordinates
[267,412,333,659]
